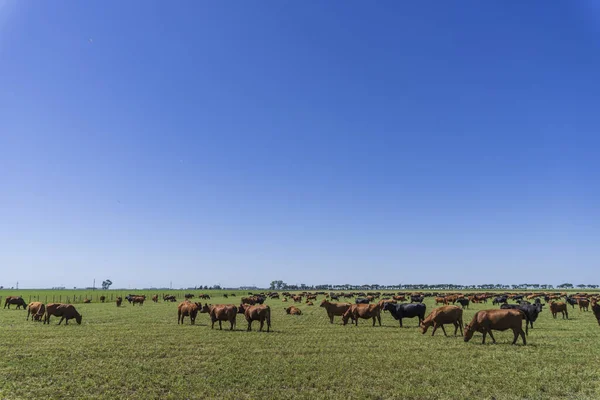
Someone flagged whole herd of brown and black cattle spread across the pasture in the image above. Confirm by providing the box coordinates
[4,292,600,344]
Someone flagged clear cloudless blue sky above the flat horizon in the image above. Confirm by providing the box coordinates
[0,0,600,287]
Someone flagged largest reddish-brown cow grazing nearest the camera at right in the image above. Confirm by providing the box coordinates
[464,309,527,346]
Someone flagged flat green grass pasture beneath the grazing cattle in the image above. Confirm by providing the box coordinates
[0,290,600,399]
